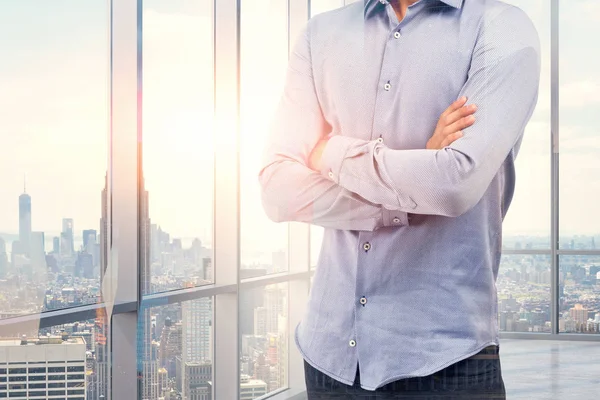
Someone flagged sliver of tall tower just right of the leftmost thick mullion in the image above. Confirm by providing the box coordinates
[137,185,160,400]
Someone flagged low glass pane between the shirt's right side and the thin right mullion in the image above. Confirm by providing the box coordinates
[496,254,552,333]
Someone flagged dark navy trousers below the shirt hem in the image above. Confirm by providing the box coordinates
[304,346,506,400]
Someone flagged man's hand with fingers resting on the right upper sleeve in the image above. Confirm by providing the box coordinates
[426,96,477,150]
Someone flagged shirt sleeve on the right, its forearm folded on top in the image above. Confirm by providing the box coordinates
[321,7,540,217]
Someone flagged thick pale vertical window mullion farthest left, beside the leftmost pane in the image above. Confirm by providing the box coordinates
[108,0,143,400]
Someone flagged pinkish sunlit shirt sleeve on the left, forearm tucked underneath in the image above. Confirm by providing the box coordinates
[259,24,408,231]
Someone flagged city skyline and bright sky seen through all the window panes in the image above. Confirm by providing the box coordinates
[0,0,600,400]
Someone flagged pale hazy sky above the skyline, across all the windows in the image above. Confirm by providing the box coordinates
[0,0,600,257]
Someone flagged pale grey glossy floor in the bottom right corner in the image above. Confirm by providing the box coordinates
[500,339,600,400]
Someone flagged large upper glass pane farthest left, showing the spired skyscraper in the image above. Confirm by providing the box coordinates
[0,0,109,318]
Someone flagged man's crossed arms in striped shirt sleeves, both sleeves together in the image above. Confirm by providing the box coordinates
[259,8,540,231]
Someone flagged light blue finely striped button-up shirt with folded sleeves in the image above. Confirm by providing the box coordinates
[259,0,540,390]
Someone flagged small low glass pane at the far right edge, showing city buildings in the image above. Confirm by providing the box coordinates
[558,256,600,334]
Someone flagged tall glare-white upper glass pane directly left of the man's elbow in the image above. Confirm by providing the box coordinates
[240,0,288,273]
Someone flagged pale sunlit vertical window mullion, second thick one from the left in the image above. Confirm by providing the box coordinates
[212,0,241,400]
